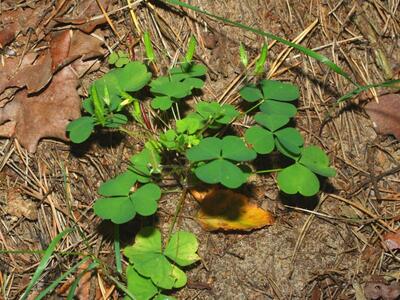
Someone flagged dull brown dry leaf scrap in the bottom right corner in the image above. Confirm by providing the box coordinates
[364,280,400,300]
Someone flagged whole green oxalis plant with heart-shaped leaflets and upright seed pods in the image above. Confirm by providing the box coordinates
[67,35,335,299]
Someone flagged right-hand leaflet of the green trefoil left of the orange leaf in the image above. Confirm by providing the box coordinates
[130,183,161,216]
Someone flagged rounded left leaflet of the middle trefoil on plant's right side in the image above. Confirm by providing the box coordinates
[244,125,275,154]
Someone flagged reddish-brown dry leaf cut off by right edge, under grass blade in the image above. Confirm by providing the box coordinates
[365,94,400,140]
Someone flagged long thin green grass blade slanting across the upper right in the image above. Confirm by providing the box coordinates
[163,0,359,87]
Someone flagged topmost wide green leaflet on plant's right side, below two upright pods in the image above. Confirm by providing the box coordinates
[260,80,300,101]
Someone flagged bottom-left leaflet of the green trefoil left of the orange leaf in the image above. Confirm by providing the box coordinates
[93,196,136,224]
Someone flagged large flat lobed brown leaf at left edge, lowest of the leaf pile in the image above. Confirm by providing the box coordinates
[0,66,81,152]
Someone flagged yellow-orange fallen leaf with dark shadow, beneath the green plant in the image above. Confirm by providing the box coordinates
[191,187,274,231]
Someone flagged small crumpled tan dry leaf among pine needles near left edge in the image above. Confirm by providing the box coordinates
[5,188,38,221]
